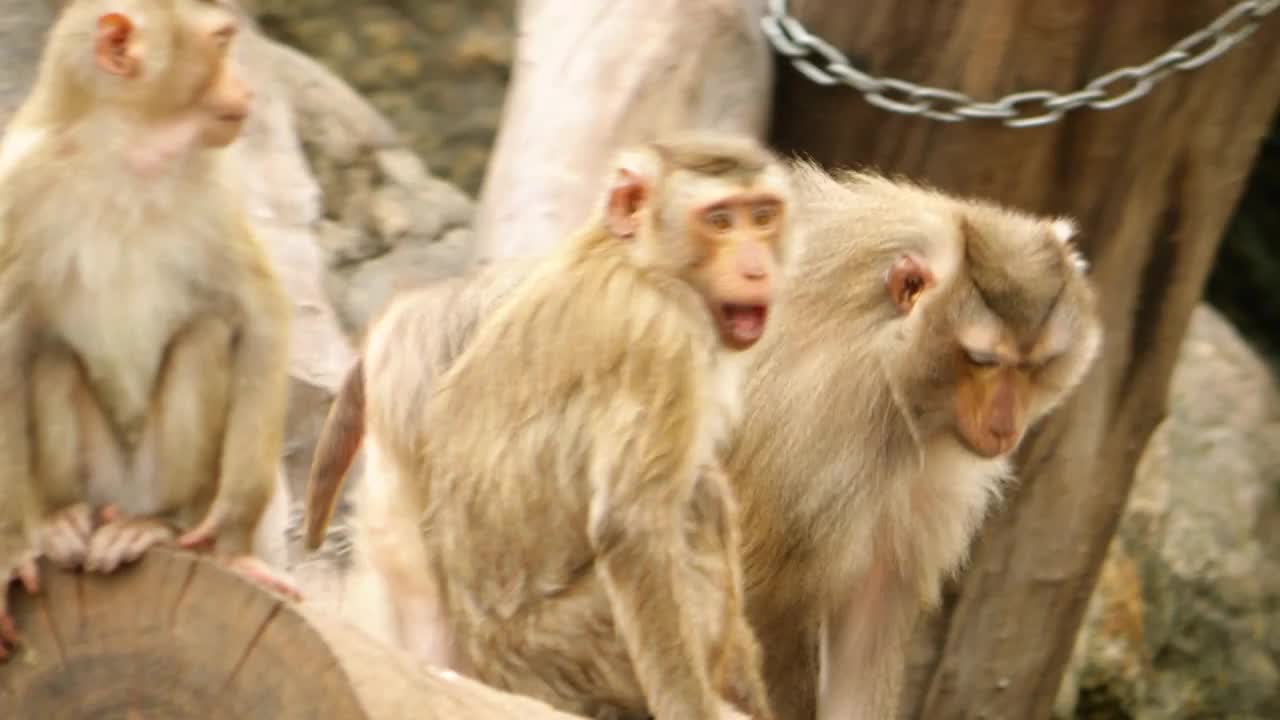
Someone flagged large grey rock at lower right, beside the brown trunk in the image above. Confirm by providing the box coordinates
[1055,306,1280,720]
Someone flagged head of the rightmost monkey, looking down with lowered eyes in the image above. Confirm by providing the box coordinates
[883,201,1101,459]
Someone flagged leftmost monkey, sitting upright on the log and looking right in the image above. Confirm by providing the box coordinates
[0,0,296,657]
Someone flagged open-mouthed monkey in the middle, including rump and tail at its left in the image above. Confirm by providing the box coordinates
[307,135,790,717]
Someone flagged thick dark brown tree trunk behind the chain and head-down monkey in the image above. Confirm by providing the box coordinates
[772,0,1280,720]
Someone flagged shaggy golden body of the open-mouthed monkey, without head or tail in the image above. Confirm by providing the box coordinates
[413,215,757,717]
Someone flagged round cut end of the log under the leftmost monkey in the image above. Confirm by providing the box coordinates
[0,550,365,720]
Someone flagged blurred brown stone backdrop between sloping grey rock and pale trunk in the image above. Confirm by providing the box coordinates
[247,0,516,193]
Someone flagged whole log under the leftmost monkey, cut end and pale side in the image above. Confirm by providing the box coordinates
[0,548,575,720]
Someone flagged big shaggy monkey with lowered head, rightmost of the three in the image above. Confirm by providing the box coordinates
[727,164,1101,719]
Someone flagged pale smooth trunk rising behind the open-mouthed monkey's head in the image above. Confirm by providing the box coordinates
[475,0,772,261]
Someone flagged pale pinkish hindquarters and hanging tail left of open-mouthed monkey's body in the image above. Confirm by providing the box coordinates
[303,260,522,653]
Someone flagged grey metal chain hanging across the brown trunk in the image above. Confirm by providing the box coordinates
[760,0,1280,128]
